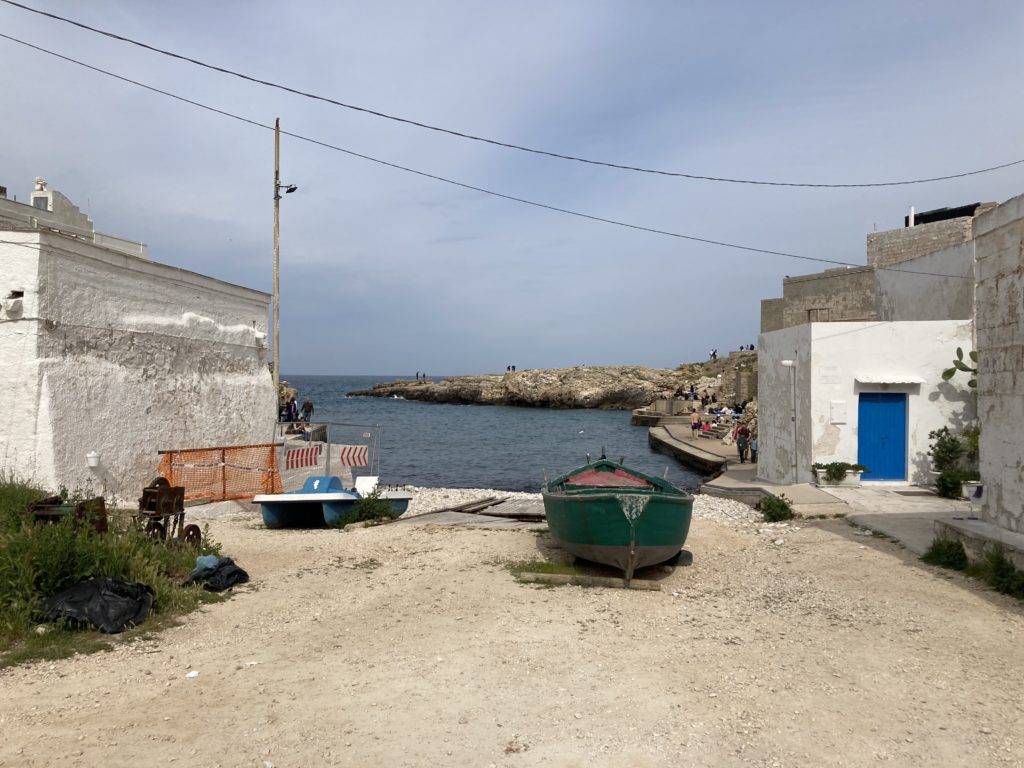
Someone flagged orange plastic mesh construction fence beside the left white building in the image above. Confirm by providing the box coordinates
[160,443,282,502]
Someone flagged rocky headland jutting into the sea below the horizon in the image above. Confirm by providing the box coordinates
[348,352,757,411]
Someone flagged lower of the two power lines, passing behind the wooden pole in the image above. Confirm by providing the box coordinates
[0,33,964,279]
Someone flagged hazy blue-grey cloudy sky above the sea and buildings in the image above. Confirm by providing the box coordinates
[0,0,1024,376]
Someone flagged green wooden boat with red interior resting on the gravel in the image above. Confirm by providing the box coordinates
[542,457,693,583]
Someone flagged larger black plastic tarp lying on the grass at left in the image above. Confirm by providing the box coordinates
[42,577,154,635]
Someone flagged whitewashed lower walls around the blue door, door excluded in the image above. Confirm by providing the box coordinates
[758,321,973,482]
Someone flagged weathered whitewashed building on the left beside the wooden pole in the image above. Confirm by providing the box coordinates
[0,179,275,500]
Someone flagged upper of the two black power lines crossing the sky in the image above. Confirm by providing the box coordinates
[8,0,1024,189]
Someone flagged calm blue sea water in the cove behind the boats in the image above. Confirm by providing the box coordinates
[283,376,700,493]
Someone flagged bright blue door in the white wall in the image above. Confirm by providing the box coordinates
[857,392,906,480]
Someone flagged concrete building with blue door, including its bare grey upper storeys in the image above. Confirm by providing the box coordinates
[758,204,992,484]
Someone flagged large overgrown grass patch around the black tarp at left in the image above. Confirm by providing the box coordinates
[0,477,220,665]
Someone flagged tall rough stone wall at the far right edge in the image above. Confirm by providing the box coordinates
[975,196,1024,534]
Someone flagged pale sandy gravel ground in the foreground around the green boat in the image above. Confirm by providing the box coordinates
[0,498,1024,768]
